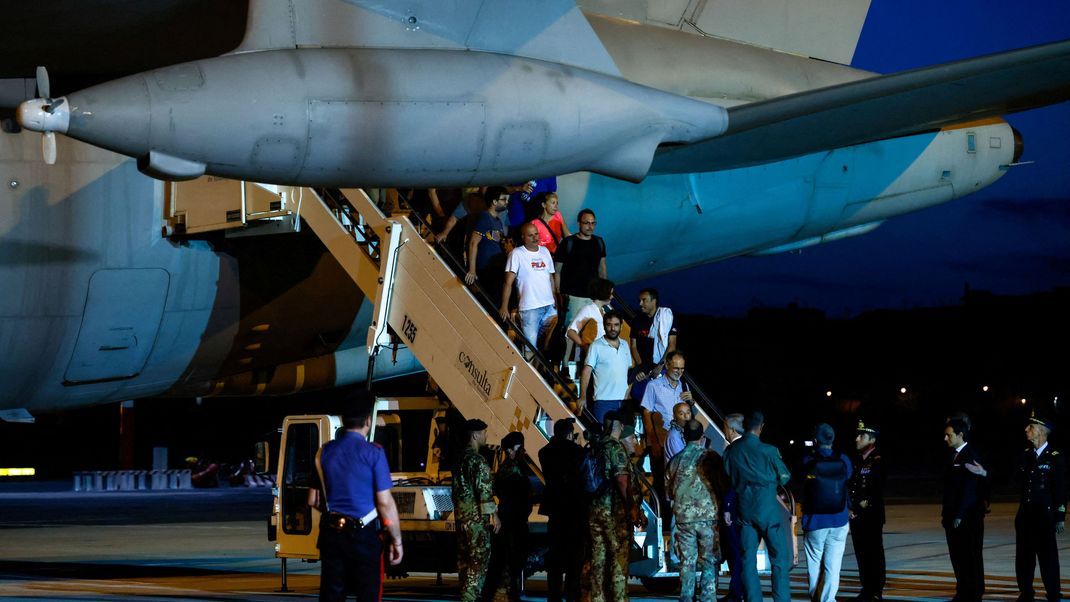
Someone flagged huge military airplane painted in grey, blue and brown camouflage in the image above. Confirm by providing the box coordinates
[0,0,1070,420]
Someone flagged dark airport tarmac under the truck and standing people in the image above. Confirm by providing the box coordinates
[0,482,1070,601]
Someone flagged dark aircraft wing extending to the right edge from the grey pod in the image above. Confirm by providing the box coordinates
[651,40,1070,174]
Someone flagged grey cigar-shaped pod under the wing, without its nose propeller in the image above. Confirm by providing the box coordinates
[29,48,728,186]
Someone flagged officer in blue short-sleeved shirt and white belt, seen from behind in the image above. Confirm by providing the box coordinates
[308,400,402,602]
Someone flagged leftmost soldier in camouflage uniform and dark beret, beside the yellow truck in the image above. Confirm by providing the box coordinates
[453,419,502,602]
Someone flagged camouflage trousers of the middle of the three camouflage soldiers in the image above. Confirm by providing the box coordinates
[581,508,631,602]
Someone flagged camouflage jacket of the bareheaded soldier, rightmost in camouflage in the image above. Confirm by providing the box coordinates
[666,442,720,523]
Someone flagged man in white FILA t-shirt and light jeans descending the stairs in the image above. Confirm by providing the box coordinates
[500,223,557,346]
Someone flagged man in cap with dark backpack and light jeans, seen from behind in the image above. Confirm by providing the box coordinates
[798,422,851,602]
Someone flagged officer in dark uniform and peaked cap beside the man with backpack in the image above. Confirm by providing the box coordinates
[847,420,887,601]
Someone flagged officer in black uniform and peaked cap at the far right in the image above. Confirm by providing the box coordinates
[1014,413,1067,601]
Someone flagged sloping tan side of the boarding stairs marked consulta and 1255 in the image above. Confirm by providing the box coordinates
[301,188,575,461]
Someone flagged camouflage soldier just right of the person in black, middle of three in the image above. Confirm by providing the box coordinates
[582,412,645,602]
